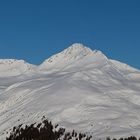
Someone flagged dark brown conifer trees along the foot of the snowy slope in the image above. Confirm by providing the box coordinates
[6,116,140,140]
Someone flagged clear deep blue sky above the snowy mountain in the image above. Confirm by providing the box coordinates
[0,0,140,69]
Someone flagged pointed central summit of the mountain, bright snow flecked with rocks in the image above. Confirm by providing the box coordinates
[40,43,107,70]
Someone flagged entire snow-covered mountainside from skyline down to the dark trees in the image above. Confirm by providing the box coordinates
[0,43,140,140]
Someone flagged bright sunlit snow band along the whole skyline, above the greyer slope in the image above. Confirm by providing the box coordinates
[0,43,136,77]
